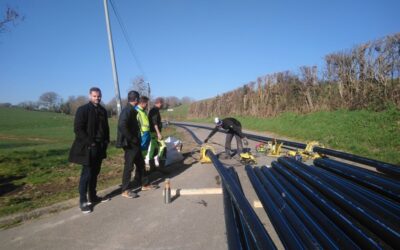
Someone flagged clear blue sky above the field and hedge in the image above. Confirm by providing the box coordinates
[0,0,400,104]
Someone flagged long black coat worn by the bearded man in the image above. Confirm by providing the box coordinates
[69,102,110,165]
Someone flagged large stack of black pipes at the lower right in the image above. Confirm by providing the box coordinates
[246,157,400,249]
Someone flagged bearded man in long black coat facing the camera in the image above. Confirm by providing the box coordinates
[69,87,110,213]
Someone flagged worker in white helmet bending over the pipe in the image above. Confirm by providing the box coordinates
[204,117,248,159]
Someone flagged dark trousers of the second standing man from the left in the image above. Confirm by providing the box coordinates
[121,146,145,192]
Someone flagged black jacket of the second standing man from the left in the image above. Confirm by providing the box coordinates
[116,103,140,148]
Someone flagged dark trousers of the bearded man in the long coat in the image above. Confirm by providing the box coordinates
[79,145,103,204]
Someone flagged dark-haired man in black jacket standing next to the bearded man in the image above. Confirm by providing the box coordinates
[116,91,144,198]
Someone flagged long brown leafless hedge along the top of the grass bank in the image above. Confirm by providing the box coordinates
[189,33,400,118]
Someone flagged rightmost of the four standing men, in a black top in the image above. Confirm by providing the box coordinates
[147,97,165,167]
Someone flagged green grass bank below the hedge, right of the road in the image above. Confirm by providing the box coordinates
[171,107,400,164]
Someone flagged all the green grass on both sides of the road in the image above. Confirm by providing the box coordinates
[0,106,400,219]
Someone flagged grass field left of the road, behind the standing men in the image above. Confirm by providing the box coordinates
[0,108,178,219]
